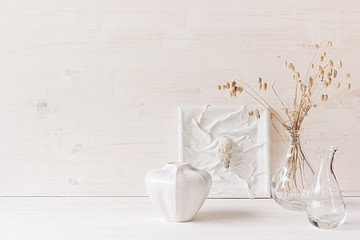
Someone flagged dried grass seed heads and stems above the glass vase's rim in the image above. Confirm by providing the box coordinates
[218,41,351,132]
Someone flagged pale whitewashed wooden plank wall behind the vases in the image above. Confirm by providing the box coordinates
[0,0,360,196]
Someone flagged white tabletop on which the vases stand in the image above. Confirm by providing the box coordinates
[0,197,360,240]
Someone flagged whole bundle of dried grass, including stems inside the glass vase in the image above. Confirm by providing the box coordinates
[218,41,351,193]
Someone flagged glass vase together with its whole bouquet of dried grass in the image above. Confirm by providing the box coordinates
[218,41,351,210]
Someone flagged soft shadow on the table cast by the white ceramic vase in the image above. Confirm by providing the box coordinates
[192,210,255,222]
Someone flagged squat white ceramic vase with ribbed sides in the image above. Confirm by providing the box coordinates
[145,162,211,222]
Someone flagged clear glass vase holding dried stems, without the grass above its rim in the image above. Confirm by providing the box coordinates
[271,130,315,211]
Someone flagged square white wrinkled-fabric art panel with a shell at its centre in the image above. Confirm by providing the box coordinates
[178,105,270,198]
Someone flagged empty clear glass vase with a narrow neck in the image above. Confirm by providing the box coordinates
[307,146,346,229]
